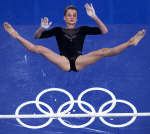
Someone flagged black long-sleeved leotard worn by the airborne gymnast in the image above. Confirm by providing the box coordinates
[40,26,102,71]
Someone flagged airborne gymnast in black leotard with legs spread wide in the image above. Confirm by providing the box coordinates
[4,4,146,72]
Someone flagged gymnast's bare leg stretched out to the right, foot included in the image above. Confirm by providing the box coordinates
[76,30,146,70]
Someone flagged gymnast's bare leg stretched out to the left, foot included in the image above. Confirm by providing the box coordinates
[4,22,70,71]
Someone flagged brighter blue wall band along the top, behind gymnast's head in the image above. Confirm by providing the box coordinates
[0,0,150,24]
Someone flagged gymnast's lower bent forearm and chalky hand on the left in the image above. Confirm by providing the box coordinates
[34,17,52,39]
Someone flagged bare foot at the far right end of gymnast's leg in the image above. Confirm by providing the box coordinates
[129,29,146,46]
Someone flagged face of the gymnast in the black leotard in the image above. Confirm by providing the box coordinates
[64,9,77,25]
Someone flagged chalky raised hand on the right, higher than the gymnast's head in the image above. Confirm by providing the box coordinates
[85,3,96,18]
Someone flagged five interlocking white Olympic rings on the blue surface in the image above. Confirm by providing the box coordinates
[15,87,137,129]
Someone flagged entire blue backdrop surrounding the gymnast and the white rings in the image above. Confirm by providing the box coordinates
[0,0,150,134]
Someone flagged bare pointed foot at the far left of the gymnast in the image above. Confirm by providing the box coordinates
[4,22,19,38]
